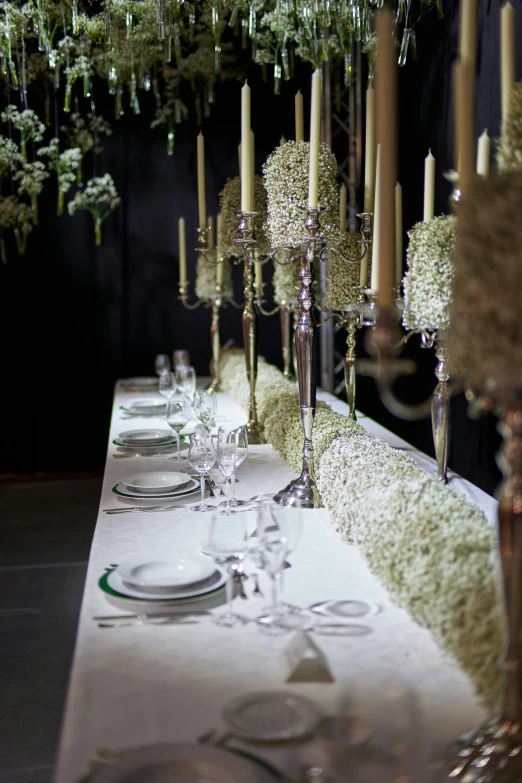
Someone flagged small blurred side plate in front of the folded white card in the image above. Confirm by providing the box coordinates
[223,691,322,742]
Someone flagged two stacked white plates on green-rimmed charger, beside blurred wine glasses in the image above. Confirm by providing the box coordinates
[107,554,227,601]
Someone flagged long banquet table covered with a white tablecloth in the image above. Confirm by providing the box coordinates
[56,384,496,783]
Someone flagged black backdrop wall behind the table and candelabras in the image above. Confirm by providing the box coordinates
[0,0,522,491]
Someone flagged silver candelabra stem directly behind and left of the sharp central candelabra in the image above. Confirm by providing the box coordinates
[243,254,264,444]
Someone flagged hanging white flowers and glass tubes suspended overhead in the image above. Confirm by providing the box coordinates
[0,0,442,250]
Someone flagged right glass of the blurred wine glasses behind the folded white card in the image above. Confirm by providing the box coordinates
[257,504,306,636]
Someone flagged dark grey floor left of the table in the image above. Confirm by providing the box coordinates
[0,478,101,783]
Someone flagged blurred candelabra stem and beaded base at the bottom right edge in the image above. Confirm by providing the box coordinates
[442,408,522,783]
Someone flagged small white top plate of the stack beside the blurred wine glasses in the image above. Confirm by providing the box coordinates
[117,554,216,588]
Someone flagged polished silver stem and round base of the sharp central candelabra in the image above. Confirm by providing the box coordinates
[274,208,322,508]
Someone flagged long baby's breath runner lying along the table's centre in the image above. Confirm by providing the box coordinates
[220,350,504,707]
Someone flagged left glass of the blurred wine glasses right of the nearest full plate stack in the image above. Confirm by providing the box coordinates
[205,513,248,628]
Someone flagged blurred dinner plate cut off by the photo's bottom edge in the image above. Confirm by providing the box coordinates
[92,743,281,783]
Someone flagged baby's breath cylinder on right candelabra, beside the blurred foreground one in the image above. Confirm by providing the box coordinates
[403,215,457,330]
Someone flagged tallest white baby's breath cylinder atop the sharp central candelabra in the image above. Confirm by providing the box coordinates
[263,141,339,248]
